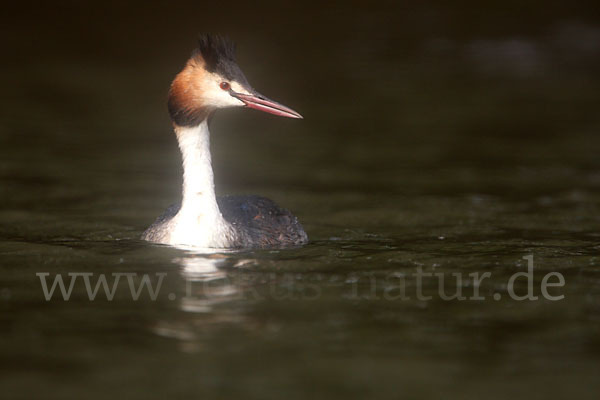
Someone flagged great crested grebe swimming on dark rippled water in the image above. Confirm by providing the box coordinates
[142,35,308,248]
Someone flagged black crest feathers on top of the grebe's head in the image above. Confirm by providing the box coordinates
[196,34,248,84]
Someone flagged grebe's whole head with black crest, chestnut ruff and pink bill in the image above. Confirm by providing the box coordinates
[168,34,302,126]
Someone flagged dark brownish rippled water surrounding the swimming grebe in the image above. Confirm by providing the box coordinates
[0,2,600,399]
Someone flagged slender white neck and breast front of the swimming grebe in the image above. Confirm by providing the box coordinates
[170,120,232,247]
